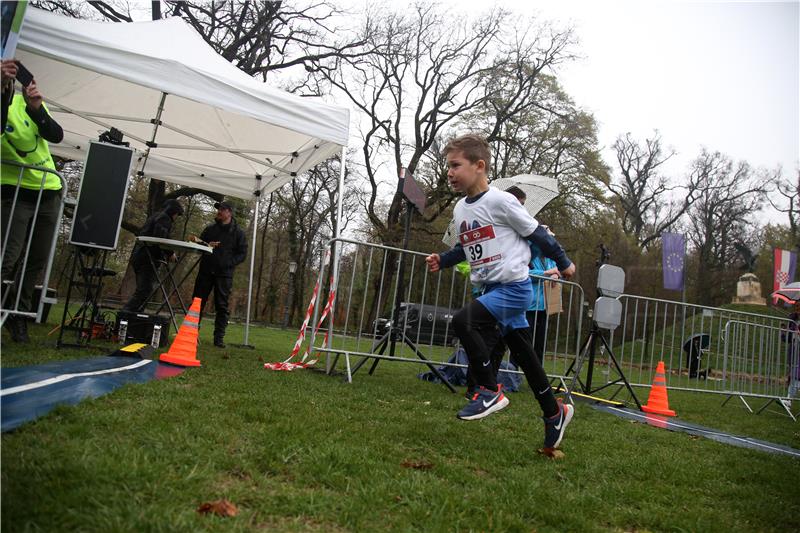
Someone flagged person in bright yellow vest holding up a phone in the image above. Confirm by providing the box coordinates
[0,60,64,342]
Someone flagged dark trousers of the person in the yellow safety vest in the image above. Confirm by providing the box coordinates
[0,190,61,311]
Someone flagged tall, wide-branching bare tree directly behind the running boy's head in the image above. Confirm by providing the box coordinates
[315,3,572,243]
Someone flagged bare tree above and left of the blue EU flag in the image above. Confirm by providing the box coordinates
[607,131,698,248]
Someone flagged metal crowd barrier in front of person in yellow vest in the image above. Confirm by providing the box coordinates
[0,160,67,323]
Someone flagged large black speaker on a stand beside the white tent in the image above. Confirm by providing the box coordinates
[57,135,133,348]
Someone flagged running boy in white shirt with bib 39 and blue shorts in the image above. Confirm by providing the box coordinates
[426,135,575,449]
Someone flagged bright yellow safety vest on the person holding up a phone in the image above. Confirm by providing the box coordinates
[0,94,61,191]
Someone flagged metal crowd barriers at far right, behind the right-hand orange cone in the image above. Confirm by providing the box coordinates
[600,294,800,418]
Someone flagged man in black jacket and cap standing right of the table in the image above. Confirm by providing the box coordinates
[193,202,247,348]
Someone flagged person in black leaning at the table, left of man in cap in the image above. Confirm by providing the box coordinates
[122,200,183,313]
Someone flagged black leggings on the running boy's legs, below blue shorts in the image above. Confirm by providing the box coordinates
[453,300,558,416]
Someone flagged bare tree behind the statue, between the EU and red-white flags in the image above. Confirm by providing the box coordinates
[688,149,766,304]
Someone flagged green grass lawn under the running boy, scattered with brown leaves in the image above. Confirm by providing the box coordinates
[2,316,800,532]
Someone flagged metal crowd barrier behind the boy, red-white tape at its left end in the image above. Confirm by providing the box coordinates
[311,239,585,382]
